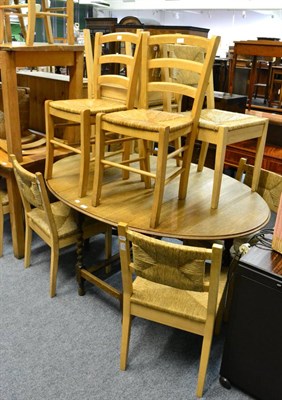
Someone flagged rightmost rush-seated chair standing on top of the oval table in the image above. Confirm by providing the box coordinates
[164,45,268,209]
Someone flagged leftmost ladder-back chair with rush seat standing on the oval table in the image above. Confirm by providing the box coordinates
[45,30,141,197]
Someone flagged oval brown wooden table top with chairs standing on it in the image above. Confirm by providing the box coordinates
[47,155,270,240]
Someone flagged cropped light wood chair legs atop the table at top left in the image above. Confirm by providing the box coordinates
[0,0,74,46]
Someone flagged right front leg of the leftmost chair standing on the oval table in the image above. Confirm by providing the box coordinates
[79,110,91,197]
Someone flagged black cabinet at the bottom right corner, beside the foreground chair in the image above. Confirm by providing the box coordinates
[220,247,282,400]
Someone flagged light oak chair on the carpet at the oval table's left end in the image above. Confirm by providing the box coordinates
[11,155,112,297]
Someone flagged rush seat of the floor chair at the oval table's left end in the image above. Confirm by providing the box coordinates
[28,201,79,239]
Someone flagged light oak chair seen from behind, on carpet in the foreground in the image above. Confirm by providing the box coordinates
[118,223,227,397]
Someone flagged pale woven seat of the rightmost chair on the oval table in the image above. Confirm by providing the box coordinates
[183,108,267,131]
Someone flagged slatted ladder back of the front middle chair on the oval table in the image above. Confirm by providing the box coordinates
[140,32,220,123]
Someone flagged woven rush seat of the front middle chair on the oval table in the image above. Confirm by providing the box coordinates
[100,109,193,132]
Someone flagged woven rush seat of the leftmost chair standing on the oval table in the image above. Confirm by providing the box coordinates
[50,99,126,115]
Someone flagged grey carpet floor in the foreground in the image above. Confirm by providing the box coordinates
[0,216,254,400]
